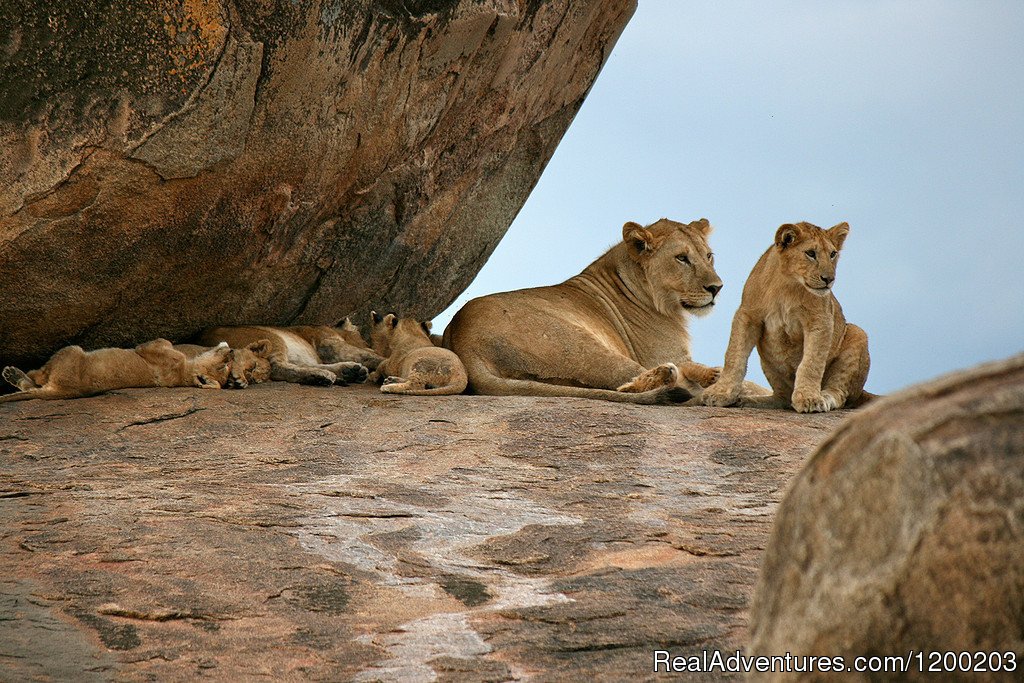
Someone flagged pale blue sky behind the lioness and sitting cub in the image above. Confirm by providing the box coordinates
[435,0,1024,392]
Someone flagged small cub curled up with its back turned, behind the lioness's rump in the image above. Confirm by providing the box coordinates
[370,311,468,396]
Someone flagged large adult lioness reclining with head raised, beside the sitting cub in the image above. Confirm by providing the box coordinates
[444,218,722,403]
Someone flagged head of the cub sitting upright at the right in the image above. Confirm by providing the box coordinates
[775,222,850,296]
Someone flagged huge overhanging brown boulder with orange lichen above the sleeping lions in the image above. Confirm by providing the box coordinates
[0,0,636,366]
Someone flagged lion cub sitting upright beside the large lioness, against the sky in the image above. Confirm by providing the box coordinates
[702,223,871,413]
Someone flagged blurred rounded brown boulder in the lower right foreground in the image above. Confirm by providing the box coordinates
[751,355,1024,680]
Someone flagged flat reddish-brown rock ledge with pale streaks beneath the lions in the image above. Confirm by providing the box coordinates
[0,384,844,681]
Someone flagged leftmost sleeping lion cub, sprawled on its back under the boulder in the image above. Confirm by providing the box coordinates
[0,339,230,402]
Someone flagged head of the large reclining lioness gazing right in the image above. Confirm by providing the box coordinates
[623,218,722,315]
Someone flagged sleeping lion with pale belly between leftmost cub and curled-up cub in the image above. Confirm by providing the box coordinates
[199,326,381,386]
